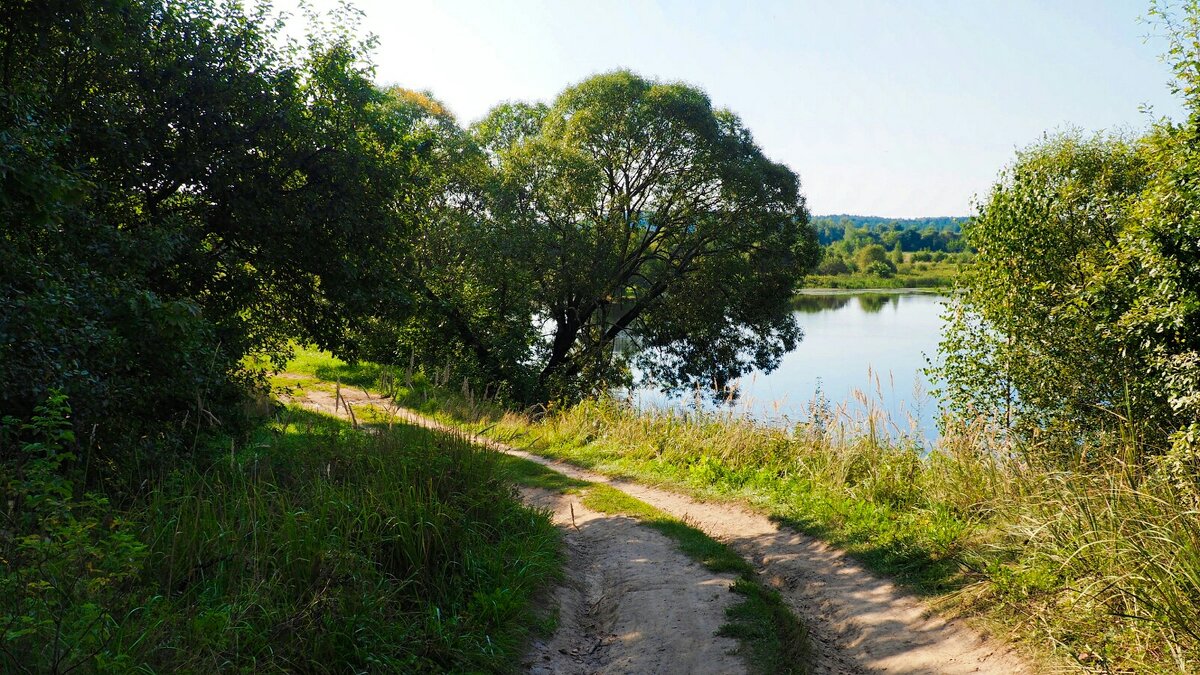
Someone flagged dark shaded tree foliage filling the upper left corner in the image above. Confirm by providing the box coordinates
[0,0,420,473]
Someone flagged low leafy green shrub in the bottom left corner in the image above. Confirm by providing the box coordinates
[0,392,146,673]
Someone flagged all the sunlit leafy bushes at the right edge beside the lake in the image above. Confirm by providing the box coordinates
[943,2,1200,466]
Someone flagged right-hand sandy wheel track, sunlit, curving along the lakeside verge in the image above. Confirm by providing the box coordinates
[285,379,1038,674]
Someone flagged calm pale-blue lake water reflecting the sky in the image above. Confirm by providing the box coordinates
[638,292,946,441]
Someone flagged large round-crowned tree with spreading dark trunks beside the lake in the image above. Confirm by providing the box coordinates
[400,71,818,399]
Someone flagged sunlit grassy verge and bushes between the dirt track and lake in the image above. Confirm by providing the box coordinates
[272,0,1200,673]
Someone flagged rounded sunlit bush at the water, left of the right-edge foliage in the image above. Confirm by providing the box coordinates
[942,133,1152,456]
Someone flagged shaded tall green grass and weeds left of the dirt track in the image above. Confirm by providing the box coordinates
[0,393,560,673]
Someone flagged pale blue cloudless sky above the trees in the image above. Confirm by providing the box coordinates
[276,0,1182,217]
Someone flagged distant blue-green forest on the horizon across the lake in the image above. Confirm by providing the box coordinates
[812,214,968,252]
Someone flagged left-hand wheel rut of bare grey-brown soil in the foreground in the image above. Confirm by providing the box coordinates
[523,490,745,675]
